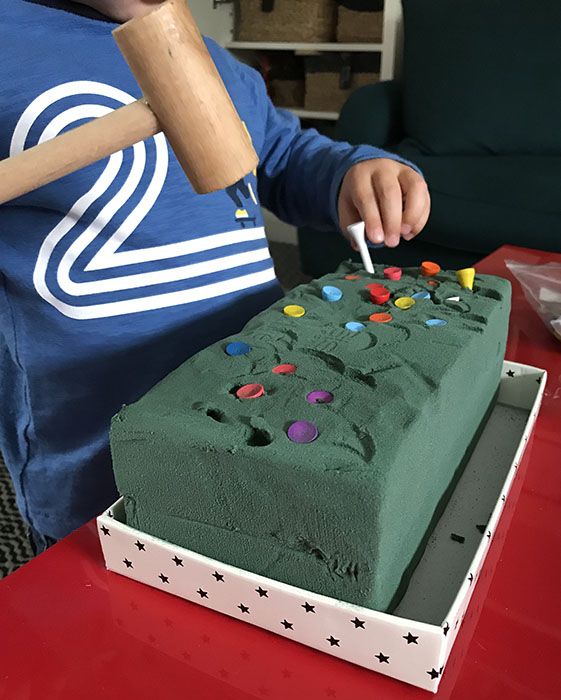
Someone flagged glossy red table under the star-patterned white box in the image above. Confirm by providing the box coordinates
[0,246,561,700]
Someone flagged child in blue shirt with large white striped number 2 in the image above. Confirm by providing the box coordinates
[0,0,429,551]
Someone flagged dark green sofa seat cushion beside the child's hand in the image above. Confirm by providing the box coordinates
[397,142,561,254]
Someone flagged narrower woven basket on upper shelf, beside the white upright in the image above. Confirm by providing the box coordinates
[337,0,384,44]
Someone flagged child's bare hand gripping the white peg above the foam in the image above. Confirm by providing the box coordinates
[338,158,430,248]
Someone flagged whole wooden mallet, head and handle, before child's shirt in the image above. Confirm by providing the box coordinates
[0,0,258,204]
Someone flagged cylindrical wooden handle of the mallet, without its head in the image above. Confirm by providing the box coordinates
[0,100,161,204]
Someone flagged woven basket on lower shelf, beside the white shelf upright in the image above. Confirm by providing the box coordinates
[304,53,380,112]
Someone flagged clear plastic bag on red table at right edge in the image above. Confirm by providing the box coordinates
[506,260,561,341]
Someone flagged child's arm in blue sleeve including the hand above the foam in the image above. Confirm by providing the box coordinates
[246,71,430,247]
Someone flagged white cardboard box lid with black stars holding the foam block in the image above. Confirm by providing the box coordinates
[97,362,547,692]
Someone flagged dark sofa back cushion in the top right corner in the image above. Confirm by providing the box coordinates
[403,0,561,155]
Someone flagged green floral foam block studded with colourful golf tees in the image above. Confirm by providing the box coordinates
[111,264,510,610]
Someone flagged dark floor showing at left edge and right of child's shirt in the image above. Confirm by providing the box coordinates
[0,242,310,578]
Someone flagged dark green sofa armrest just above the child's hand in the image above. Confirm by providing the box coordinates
[335,80,403,148]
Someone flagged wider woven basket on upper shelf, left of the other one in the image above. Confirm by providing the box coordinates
[235,0,337,43]
